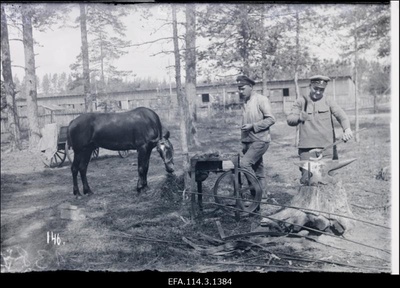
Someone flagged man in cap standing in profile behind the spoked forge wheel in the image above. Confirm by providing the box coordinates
[236,76,275,196]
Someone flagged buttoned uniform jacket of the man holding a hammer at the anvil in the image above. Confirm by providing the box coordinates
[287,96,350,148]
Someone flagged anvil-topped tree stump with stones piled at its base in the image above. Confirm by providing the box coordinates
[261,159,356,235]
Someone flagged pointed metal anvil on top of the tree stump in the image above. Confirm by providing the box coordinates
[294,158,357,185]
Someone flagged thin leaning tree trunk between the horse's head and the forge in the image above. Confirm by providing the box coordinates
[171,4,190,189]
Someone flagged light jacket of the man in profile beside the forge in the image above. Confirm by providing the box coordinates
[241,92,275,142]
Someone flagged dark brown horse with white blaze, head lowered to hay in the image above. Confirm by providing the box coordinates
[67,107,174,196]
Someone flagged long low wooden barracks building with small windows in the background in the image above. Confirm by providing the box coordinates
[17,76,355,114]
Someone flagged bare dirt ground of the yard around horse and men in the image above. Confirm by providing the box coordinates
[1,114,391,273]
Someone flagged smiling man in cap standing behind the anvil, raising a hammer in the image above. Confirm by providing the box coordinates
[287,75,353,184]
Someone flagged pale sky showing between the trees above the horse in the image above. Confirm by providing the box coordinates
[9,5,174,81]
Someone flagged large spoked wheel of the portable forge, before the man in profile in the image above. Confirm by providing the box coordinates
[214,168,262,216]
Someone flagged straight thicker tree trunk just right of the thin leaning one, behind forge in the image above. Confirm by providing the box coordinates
[185,4,200,146]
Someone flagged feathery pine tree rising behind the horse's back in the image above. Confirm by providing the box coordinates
[70,4,130,111]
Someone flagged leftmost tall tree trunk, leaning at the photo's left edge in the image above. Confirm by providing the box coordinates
[1,6,22,151]
